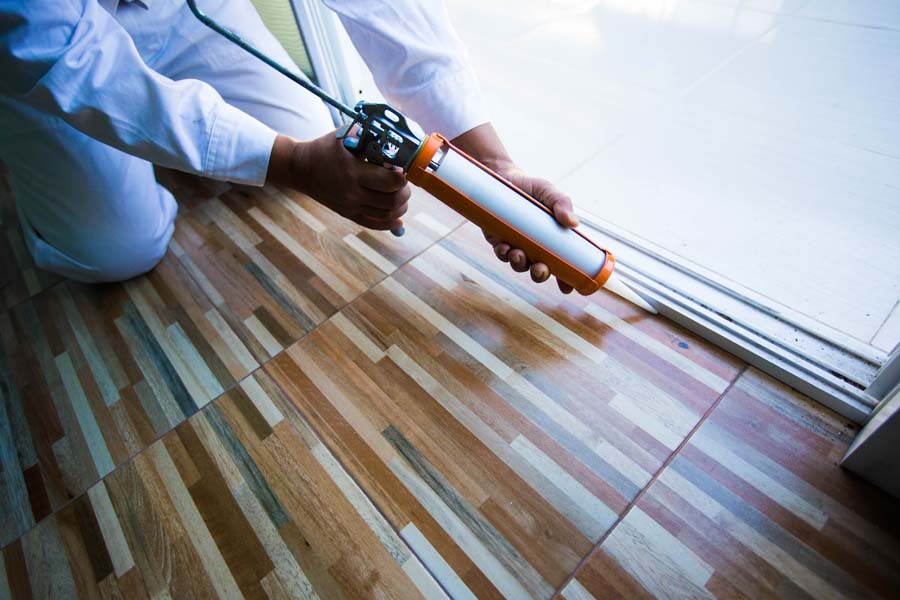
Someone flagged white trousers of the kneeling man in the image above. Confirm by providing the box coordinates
[0,0,334,282]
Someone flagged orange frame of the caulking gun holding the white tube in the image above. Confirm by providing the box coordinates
[406,133,616,296]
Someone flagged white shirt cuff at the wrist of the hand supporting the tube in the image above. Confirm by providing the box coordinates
[404,66,490,140]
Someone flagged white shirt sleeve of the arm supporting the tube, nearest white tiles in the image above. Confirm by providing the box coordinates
[324,0,488,139]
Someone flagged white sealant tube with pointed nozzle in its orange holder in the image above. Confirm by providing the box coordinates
[407,134,656,312]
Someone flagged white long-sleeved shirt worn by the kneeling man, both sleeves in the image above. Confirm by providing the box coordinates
[0,0,487,185]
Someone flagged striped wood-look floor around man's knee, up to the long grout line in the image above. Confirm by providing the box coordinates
[0,176,462,548]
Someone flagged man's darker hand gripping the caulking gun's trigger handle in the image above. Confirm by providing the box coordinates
[266,132,410,230]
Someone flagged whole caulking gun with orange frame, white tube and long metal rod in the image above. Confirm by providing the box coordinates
[187,0,656,313]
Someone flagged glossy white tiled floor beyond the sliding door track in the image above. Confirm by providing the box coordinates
[447,0,900,351]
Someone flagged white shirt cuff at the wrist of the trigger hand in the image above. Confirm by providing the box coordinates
[203,102,277,186]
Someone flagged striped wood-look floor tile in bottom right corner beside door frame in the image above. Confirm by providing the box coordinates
[564,369,900,598]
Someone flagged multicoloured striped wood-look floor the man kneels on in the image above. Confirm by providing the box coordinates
[0,175,900,599]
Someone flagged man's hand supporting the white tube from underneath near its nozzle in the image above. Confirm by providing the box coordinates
[453,123,578,294]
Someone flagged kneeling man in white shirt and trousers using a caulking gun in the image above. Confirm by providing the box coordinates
[0,0,577,292]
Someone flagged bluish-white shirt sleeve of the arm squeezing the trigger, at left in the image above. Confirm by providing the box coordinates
[0,0,276,185]
